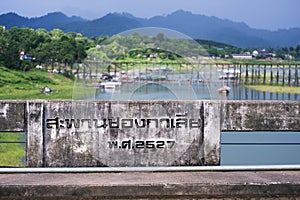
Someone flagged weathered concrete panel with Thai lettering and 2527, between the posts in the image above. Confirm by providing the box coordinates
[45,101,204,167]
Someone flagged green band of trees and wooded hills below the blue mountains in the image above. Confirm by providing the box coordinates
[0,26,300,71]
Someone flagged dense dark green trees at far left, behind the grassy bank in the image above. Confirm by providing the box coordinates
[0,27,101,70]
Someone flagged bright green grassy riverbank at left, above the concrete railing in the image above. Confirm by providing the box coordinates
[0,66,73,100]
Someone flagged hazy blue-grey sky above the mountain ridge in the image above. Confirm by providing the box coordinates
[0,0,300,30]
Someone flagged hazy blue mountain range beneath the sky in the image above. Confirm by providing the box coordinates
[0,10,300,48]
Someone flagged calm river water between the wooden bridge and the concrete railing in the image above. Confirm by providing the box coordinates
[96,83,300,101]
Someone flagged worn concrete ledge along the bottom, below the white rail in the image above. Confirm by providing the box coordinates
[0,170,300,199]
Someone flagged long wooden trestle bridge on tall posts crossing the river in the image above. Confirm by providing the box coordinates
[69,62,300,87]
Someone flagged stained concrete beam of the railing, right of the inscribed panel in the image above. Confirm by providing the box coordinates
[222,101,300,131]
